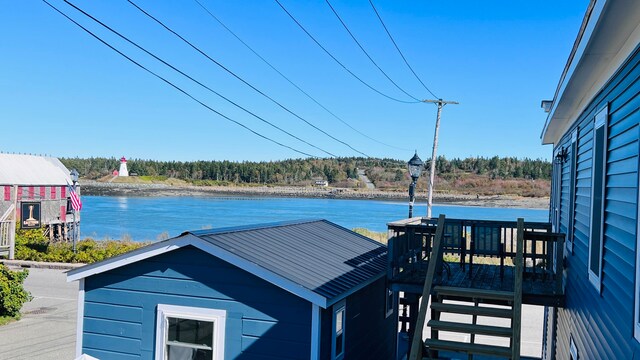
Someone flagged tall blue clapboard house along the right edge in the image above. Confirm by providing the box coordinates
[542,0,640,359]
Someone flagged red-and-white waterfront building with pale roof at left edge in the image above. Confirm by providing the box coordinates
[0,153,80,257]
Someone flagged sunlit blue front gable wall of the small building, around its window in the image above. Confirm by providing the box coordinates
[83,247,311,360]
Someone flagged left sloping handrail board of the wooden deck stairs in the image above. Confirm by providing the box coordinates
[409,214,445,360]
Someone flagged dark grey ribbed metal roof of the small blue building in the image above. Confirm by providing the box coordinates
[67,220,387,308]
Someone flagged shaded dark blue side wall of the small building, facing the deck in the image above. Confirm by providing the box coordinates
[320,278,398,360]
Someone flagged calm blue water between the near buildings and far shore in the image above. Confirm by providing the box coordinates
[81,196,548,241]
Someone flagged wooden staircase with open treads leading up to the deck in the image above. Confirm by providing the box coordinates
[409,219,524,360]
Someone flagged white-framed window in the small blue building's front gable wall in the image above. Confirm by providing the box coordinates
[156,304,226,360]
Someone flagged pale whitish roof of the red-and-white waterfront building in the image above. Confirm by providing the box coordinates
[0,154,71,186]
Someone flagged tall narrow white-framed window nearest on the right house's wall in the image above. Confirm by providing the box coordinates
[589,106,608,292]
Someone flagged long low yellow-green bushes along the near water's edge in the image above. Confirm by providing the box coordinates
[15,229,148,263]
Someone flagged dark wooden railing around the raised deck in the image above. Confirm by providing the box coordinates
[387,219,564,289]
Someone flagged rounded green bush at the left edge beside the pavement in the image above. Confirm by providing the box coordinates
[0,264,32,317]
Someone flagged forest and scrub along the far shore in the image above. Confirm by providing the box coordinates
[60,156,551,197]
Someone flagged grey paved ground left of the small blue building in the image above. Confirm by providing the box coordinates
[0,268,78,360]
